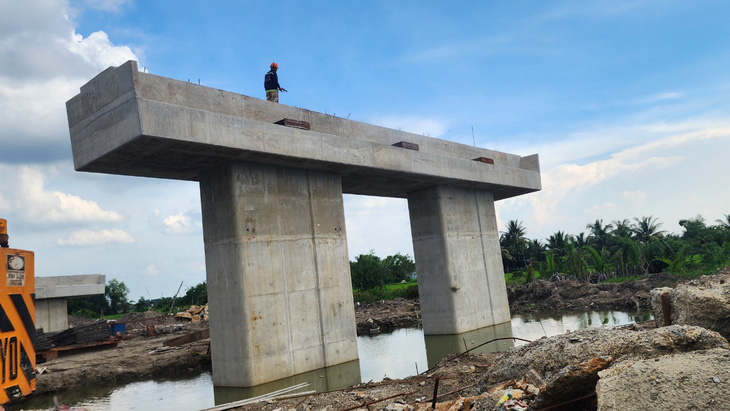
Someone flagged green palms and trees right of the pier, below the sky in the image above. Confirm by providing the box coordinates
[499,214,730,282]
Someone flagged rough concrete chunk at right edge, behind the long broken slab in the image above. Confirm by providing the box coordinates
[651,268,730,338]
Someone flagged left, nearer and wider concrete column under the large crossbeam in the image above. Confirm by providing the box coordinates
[200,162,358,387]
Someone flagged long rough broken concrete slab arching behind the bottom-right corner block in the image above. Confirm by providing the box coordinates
[472,325,730,409]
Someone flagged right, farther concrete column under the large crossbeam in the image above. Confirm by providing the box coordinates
[408,186,510,335]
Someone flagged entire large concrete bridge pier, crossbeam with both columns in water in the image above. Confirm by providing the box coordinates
[66,61,541,387]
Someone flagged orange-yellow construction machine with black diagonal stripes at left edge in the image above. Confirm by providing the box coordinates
[0,219,36,404]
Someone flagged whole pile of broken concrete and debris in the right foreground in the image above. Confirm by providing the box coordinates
[228,272,730,411]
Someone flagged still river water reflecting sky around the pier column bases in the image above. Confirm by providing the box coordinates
[17,311,653,411]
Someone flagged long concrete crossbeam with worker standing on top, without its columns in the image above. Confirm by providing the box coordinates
[66,61,540,200]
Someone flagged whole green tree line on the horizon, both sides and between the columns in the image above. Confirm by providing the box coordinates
[68,214,730,318]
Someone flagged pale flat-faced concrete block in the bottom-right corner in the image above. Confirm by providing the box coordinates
[596,348,730,411]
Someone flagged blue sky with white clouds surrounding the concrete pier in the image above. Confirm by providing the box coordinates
[0,0,730,300]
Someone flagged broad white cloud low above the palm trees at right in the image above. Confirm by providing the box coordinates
[498,121,730,237]
